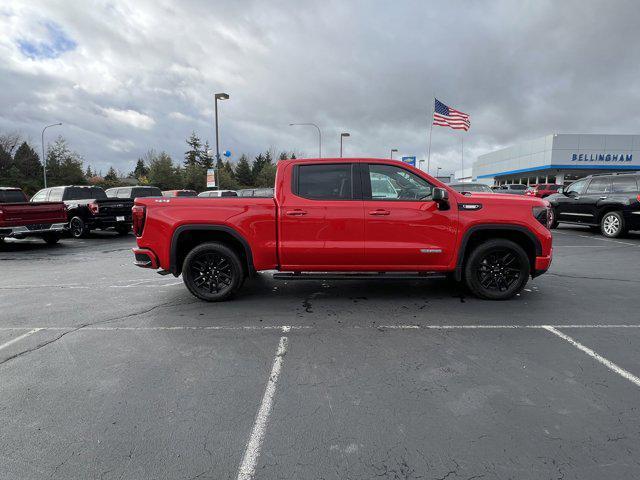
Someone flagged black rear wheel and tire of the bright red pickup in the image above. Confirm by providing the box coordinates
[182,242,245,302]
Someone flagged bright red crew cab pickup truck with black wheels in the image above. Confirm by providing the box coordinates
[133,158,552,301]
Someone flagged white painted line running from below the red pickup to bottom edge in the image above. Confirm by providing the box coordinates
[238,326,290,480]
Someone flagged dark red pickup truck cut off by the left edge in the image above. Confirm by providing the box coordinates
[0,187,67,244]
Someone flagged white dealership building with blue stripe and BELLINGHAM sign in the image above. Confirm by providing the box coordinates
[472,134,640,185]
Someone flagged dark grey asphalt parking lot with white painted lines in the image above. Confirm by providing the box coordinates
[0,227,640,480]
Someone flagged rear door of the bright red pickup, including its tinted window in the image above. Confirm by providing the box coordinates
[278,162,364,271]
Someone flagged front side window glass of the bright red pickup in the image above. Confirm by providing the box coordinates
[369,163,433,201]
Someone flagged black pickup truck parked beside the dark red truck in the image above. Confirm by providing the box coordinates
[31,185,133,238]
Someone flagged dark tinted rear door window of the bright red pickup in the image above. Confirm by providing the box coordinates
[294,163,353,200]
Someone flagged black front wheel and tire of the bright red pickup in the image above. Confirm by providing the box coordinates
[464,238,531,300]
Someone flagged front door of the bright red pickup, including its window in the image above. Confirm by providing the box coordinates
[361,163,458,271]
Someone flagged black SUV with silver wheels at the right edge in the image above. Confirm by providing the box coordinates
[546,172,640,238]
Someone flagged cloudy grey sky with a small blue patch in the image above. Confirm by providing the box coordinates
[0,0,640,176]
